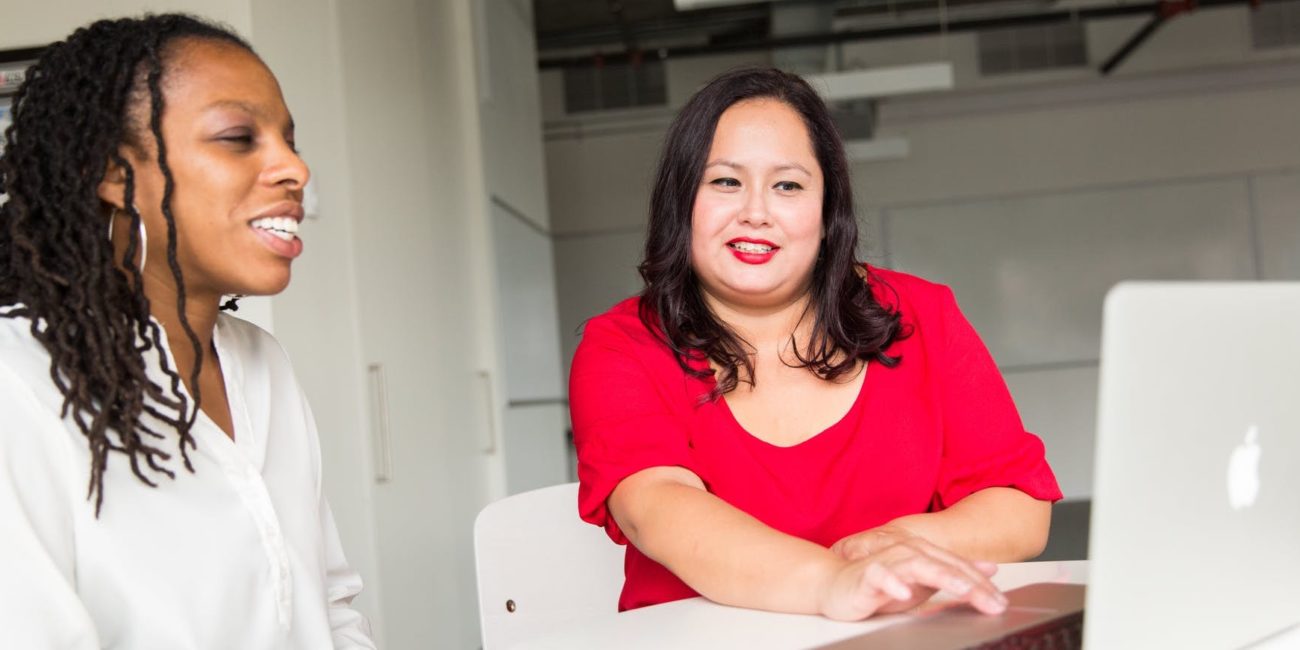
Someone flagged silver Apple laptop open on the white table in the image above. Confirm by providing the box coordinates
[826,282,1300,650]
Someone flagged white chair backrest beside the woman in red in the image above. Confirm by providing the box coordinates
[475,484,624,650]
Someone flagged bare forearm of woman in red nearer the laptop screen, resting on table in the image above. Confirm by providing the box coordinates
[887,488,1052,562]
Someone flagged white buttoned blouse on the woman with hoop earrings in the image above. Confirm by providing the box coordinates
[0,315,374,650]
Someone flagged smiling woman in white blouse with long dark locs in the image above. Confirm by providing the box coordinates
[0,14,373,649]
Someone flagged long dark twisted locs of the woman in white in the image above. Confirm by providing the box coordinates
[0,14,252,516]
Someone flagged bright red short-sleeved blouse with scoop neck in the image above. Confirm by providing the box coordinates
[569,268,1061,611]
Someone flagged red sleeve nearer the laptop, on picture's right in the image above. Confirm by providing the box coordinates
[930,287,1061,510]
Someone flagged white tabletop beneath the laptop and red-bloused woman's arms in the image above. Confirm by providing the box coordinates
[516,562,1300,650]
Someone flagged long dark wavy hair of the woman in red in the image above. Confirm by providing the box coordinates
[638,68,904,399]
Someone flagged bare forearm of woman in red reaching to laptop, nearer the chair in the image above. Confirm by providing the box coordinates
[610,468,846,614]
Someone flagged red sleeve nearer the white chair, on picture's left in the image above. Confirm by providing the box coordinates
[569,315,693,543]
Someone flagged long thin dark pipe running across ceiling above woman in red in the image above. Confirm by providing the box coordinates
[537,0,1253,70]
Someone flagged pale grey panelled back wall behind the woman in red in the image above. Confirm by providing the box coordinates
[542,8,1300,497]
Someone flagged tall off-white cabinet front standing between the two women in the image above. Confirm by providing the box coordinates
[337,0,494,647]
